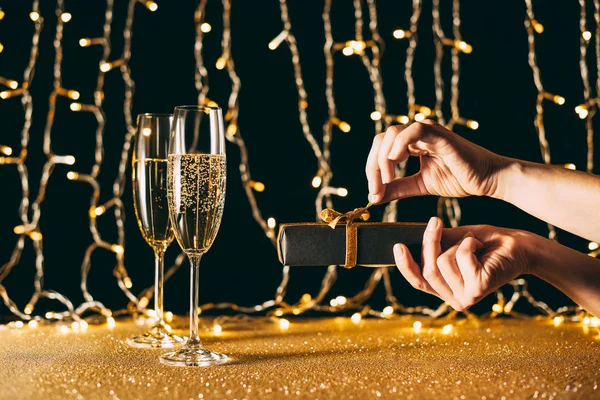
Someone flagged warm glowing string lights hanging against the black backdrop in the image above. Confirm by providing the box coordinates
[0,0,600,335]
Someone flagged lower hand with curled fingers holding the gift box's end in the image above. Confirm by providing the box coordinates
[394,217,541,311]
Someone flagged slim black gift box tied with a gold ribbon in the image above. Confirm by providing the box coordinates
[277,222,427,267]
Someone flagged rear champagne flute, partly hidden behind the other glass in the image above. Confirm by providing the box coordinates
[127,114,185,348]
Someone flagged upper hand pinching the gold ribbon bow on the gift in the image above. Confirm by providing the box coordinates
[366,120,506,204]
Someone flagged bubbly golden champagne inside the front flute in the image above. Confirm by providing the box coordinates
[167,154,227,256]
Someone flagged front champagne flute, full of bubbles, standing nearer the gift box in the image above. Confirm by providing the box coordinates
[160,106,229,366]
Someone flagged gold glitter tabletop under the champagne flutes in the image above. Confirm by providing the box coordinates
[0,318,600,400]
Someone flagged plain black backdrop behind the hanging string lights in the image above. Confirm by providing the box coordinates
[0,0,596,314]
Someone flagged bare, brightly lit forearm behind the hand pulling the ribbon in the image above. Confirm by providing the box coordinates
[492,158,600,241]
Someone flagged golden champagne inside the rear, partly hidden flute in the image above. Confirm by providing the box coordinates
[133,158,173,249]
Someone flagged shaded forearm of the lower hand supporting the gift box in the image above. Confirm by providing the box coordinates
[527,234,600,317]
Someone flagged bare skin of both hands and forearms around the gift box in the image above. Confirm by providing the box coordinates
[366,120,600,316]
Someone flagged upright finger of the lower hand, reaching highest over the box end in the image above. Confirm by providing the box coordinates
[422,217,457,308]
